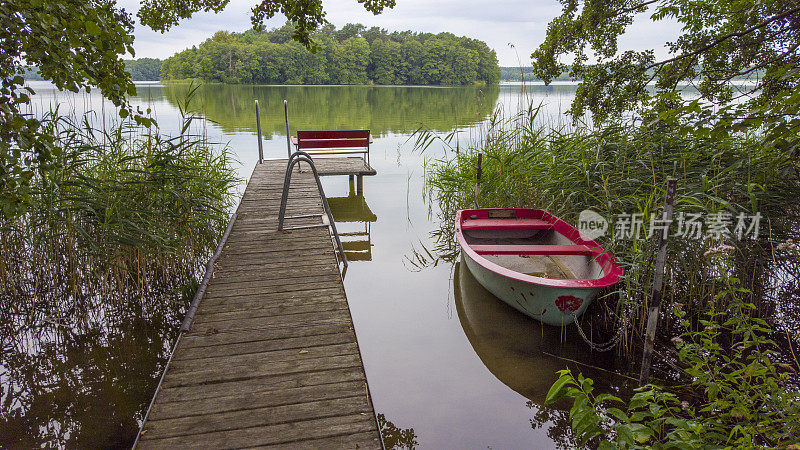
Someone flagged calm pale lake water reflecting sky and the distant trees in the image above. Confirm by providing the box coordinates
[0,83,625,449]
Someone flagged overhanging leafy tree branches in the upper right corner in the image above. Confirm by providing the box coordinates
[531,0,800,154]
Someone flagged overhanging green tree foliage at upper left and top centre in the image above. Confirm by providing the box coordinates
[0,0,395,217]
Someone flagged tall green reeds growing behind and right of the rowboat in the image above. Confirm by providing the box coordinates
[422,106,800,356]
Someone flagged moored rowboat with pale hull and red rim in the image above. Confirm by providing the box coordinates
[455,208,623,326]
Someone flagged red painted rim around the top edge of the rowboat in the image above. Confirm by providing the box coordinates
[455,208,624,289]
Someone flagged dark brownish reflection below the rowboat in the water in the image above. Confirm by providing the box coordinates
[453,260,633,446]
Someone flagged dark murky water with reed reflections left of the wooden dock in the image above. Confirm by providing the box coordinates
[0,288,190,448]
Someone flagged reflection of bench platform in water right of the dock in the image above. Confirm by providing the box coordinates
[328,189,378,261]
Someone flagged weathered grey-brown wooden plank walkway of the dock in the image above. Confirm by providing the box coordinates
[138,158,382,448]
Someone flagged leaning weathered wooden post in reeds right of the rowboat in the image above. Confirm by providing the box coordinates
[639,178,678,386]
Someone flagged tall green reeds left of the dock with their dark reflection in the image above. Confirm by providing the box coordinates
[0,106,237,447]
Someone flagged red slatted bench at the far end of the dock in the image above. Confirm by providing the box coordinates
[292,130,372,164]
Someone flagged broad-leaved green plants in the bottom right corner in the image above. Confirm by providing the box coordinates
[547,278,800,449]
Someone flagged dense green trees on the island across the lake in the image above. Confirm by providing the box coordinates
[161,24,500,86]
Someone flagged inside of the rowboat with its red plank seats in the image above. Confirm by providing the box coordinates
[461,210,604,279]
